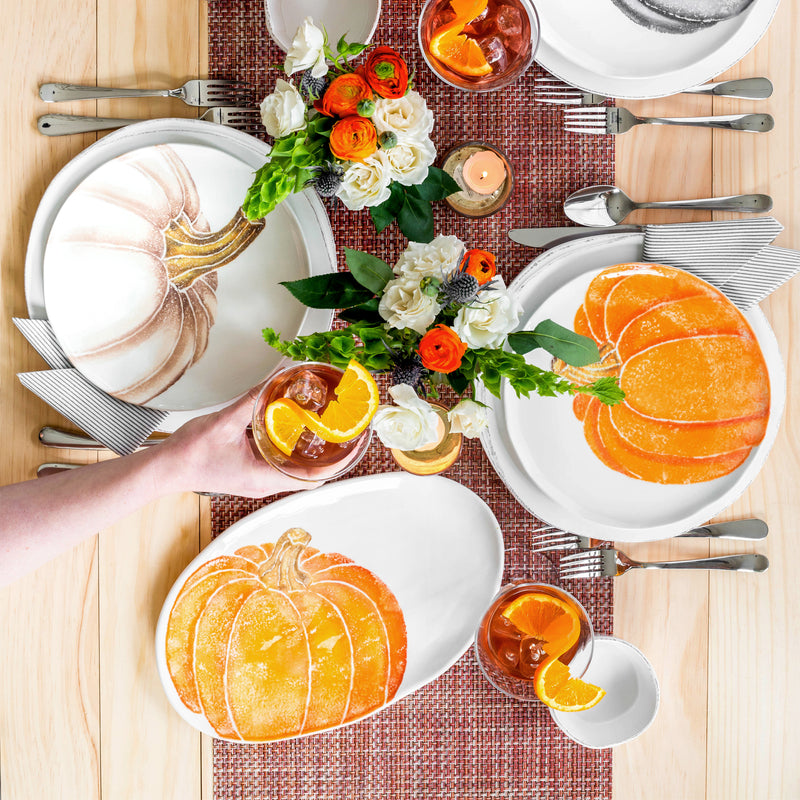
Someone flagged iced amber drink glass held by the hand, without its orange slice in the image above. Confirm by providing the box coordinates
[253,362,372,481]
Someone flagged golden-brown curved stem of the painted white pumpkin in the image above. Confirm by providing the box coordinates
[163,208,264,289]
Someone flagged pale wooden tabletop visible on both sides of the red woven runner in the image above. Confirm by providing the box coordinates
[0,0,800,800]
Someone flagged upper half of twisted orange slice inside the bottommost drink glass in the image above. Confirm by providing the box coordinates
[502,592,581,656]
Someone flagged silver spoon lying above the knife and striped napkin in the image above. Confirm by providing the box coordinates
[564,186,772,227]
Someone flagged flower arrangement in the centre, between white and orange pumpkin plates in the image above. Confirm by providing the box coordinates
[264,236,624,450]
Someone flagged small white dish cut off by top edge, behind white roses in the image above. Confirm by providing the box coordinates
[264,0,381,53]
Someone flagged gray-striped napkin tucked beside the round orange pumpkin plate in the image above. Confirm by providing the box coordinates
[644,217,800,310]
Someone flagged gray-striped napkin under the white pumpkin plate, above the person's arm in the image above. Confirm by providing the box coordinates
[14,318,168,456]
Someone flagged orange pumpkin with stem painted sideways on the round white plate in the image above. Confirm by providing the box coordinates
[553,264,770,484]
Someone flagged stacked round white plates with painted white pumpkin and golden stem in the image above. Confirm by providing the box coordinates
[25,119,336,430]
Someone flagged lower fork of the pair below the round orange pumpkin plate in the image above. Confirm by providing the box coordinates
[558,547,769,580]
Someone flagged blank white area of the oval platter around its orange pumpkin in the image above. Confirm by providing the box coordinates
[156,472,504,738]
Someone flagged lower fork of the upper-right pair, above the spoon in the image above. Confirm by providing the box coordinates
[564,106,775,133]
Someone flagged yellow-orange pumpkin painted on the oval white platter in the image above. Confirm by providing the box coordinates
[166,528,406,742]
